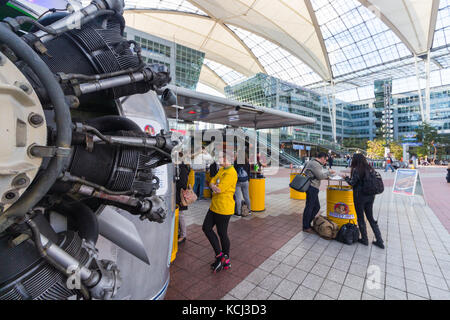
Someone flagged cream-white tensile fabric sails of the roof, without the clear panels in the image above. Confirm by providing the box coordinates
[125,0,439,87]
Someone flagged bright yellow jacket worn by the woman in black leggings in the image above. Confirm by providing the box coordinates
[209,166,237,215]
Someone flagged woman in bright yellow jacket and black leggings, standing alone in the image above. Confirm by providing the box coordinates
[202,151,237,272]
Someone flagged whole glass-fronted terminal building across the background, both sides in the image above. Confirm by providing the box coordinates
[126,27,450,155]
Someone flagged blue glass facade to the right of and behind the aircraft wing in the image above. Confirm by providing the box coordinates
[225,74,450,142]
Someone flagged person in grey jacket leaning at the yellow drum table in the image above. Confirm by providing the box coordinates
[303,152,336,233]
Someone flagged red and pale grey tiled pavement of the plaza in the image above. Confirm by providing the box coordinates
[165,168,450,300]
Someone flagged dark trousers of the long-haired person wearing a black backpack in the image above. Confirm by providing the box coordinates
[353,195,383,242]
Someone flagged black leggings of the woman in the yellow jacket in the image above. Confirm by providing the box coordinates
[202,210,231,256]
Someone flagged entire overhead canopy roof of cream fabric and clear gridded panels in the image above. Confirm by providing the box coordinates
[121,0,450,91]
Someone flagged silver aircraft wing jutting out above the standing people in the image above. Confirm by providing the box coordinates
[166,85,316,129]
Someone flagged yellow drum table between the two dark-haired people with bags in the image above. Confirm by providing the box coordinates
[327,183,358,228]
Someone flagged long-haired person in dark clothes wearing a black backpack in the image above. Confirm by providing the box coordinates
[343,153,384,249]
